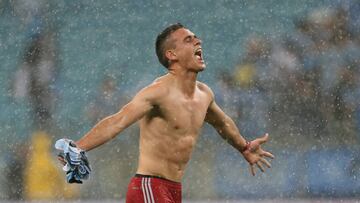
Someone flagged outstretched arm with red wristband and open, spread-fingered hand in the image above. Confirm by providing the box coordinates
[205,90,274,175]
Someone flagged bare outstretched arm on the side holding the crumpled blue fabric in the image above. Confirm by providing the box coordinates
[75,84,161,151]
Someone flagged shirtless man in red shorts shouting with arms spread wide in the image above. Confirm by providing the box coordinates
[59,24,273,203]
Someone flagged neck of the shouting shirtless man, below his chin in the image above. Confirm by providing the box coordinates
[169,65,197,98]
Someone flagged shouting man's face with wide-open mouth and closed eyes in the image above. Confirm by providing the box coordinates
[171,28,206,72]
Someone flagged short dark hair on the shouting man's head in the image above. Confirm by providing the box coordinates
[155,23,185,68]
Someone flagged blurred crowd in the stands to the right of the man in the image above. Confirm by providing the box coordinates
[217,4,360,149]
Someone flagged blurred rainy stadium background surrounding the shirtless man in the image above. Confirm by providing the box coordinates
[0,0,360,202]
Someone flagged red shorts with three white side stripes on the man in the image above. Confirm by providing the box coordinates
[126,174,181,203]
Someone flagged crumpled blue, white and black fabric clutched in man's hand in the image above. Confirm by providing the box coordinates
[55,139,91,184]
